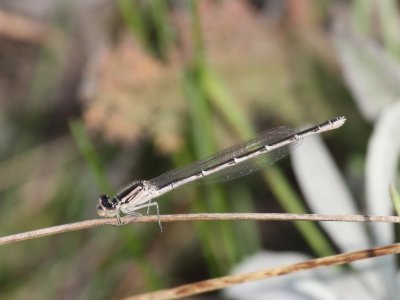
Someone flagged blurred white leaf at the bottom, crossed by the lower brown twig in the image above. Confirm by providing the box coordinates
[224,251,382,300]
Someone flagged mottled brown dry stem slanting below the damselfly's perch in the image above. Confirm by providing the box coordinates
[124,244,400,300]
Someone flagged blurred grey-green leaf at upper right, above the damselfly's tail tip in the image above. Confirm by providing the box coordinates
[333,30,400,121]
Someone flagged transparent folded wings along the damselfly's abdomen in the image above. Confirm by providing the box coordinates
[150,126,298,188]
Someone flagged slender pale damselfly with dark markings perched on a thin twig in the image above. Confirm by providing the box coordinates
[97,117,346,227]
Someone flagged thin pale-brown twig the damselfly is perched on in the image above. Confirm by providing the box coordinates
[0,213,400,245]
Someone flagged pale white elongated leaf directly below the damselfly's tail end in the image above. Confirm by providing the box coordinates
[291,132,369,251]
